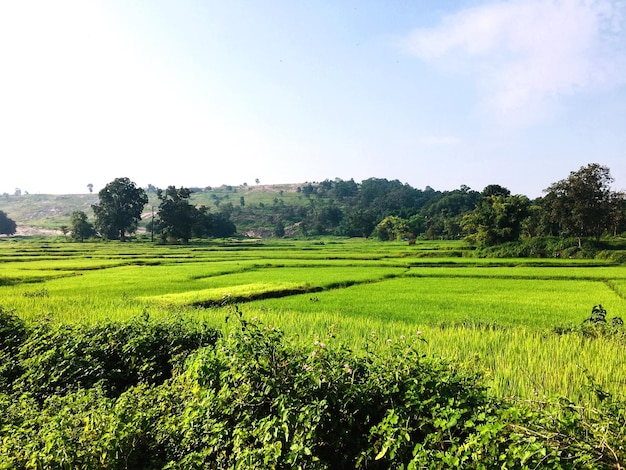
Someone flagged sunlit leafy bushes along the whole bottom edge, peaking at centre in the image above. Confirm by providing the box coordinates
[0,309,626,469]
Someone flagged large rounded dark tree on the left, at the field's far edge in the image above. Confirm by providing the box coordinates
[91,178,148,241]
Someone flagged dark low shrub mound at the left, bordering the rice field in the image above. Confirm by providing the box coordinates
[4,315,219,400]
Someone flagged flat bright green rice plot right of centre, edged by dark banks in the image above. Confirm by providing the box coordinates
[246,277,626,328]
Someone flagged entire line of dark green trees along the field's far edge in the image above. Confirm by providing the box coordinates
[0,163,626,247]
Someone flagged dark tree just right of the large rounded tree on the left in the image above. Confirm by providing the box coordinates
[157,186,198,243]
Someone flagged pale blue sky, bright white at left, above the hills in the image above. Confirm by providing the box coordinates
[0,0,626,198]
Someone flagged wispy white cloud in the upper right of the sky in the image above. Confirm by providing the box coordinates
[405,0,626,122]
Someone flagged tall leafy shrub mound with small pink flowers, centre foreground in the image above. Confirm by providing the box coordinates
[168,314,487,468]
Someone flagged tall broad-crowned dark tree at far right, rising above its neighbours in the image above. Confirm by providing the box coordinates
[543,163,620,247]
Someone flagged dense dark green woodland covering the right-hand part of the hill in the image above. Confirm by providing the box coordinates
[227,163,626,246]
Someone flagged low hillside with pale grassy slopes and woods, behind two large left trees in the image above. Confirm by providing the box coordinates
[0,173,626,246]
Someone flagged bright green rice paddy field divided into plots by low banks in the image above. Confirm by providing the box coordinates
[0,239,626,402]
